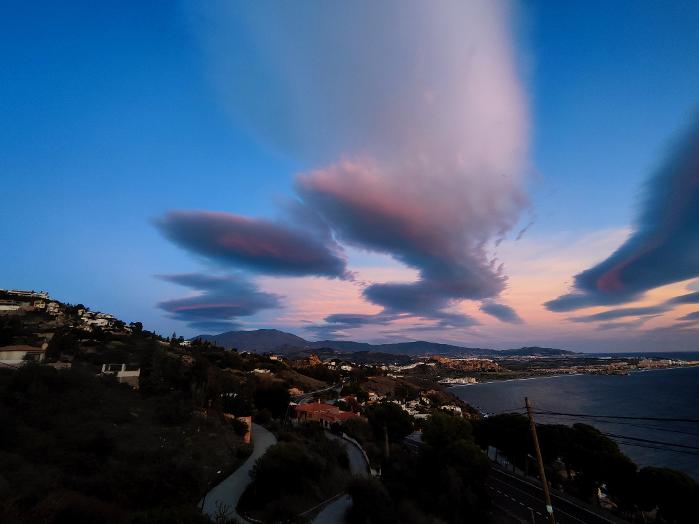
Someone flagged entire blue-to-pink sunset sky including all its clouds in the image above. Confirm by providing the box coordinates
[0,0,699,352]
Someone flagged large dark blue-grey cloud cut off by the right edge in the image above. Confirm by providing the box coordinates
[545,121,699,311]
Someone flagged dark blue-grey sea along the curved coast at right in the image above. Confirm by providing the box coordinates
[450,362,699,481]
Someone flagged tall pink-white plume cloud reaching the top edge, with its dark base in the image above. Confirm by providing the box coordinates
[174,0,528,326]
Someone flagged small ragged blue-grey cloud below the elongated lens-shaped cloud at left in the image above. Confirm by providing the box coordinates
[158,273,281,330]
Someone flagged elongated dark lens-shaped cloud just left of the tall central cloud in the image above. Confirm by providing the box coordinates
[156,211,349,278]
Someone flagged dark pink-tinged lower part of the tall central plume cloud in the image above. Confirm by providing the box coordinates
[296,161,525,325]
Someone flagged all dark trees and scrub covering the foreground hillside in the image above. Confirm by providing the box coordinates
[0,298,699,524]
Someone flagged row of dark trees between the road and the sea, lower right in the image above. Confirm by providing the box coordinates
[475,414,699,524]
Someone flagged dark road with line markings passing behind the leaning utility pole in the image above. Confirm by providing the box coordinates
[487,467,624,524]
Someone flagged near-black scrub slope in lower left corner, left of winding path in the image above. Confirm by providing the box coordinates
[0,365,246,523]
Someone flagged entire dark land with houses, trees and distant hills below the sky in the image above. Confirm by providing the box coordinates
[0,291,696,524]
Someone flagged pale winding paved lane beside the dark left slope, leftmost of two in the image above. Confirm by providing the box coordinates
[200,423,277,522]
